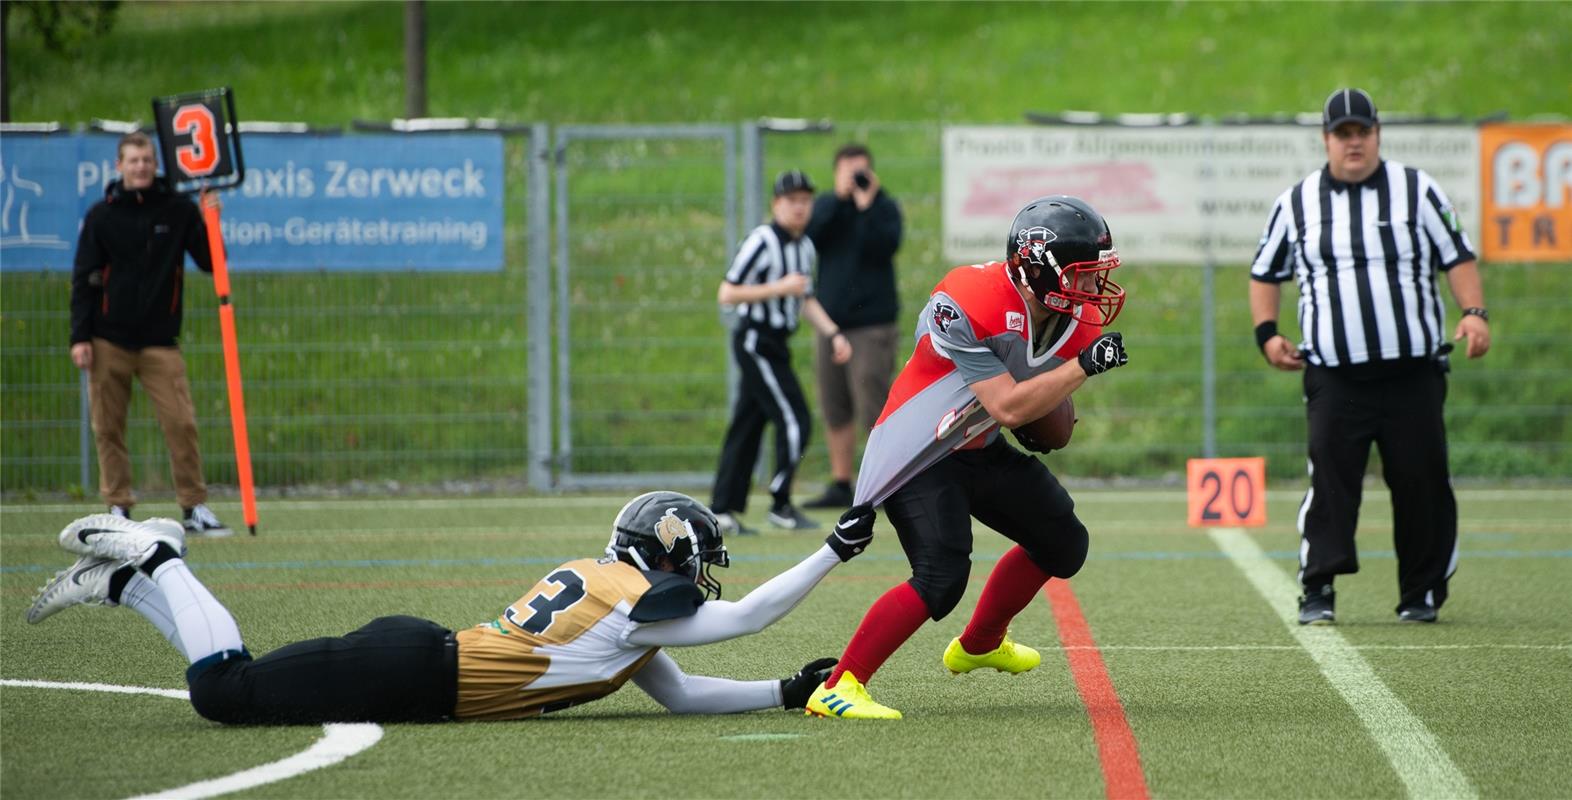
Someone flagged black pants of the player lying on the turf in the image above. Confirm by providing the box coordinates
[185,616,459,725]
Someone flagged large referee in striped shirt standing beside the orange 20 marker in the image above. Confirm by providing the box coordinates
[1250,88,1490,626]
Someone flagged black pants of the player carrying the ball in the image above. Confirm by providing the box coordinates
[883,435,1086,621]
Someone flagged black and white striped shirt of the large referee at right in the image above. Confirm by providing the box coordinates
[1250,160,1475,366]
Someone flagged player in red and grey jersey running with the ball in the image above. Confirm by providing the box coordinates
[806,195,1127,718]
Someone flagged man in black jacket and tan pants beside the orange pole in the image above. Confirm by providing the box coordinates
[71,132,230,536]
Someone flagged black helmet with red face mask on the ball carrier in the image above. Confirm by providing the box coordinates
[1005,195,1124,325]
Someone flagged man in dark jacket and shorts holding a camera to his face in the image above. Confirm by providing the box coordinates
[806,143,901,508]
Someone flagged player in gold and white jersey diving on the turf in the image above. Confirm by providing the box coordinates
[27,492,874,725]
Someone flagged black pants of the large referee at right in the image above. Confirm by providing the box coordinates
[1298,358,1457,610]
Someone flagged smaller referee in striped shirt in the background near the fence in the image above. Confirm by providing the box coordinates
[711,170,852,533]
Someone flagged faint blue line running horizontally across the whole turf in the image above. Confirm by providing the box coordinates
[0,550,1572,574]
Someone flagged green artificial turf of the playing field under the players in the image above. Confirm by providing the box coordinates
[0,486,1572,800]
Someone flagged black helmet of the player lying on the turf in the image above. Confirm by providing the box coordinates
[605,492,731,599]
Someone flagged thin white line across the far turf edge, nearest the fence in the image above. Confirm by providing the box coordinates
[0,489,1572,514]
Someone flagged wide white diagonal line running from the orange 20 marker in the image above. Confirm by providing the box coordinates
[1207,528,1478,798]
